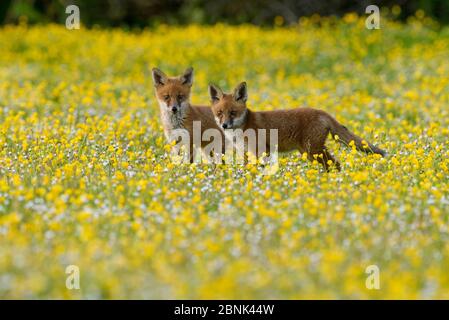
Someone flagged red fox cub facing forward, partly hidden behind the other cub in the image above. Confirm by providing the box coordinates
[152,68,224,161]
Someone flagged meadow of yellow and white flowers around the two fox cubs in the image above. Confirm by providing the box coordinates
[0,11,449,299]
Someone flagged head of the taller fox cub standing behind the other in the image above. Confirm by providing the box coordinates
[152,68,193,114]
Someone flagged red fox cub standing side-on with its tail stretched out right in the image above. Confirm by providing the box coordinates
[209,82,385,170]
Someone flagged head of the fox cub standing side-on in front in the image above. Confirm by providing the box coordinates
[209,82,248,129]
